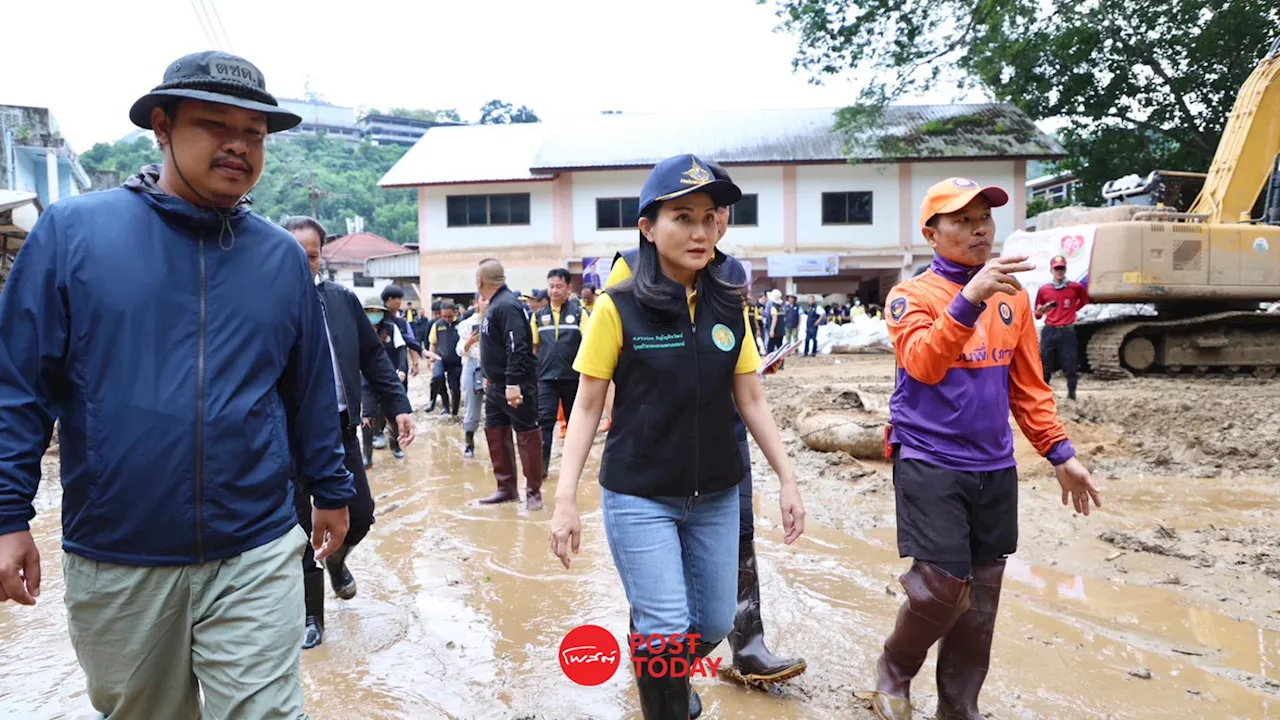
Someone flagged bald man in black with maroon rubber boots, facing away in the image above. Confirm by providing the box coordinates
[476,258,543,510]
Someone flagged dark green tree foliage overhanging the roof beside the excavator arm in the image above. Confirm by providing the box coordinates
[756,0,1280,202]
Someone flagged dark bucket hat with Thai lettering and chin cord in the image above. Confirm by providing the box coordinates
[129,50,302,132]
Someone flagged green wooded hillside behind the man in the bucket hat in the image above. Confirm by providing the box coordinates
[79,135,417,243]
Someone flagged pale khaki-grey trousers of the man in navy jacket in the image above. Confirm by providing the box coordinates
[63,527,308,720]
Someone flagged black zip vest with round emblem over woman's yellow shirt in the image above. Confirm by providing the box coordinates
[600,283,746,497]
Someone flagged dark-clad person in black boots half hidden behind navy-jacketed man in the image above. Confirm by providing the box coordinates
[284,217,415,648]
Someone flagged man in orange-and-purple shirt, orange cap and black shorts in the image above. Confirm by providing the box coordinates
[872,178,1102,720]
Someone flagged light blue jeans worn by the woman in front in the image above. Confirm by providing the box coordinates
[600,487,739,646]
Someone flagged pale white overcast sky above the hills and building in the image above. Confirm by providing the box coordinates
[0,0,984,152]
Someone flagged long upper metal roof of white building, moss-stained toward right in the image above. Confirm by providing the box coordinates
[532,104,1065,172]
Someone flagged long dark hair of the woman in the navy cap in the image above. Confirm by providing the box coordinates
[618,197,746,319]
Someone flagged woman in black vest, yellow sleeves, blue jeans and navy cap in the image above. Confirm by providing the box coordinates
[550,155,804,720]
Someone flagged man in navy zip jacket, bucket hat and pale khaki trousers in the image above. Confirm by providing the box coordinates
[0,51,355,720]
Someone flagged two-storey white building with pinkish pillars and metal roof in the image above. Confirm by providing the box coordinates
[380,105,1064,301]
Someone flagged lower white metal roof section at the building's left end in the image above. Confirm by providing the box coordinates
[378,123,552,187]
